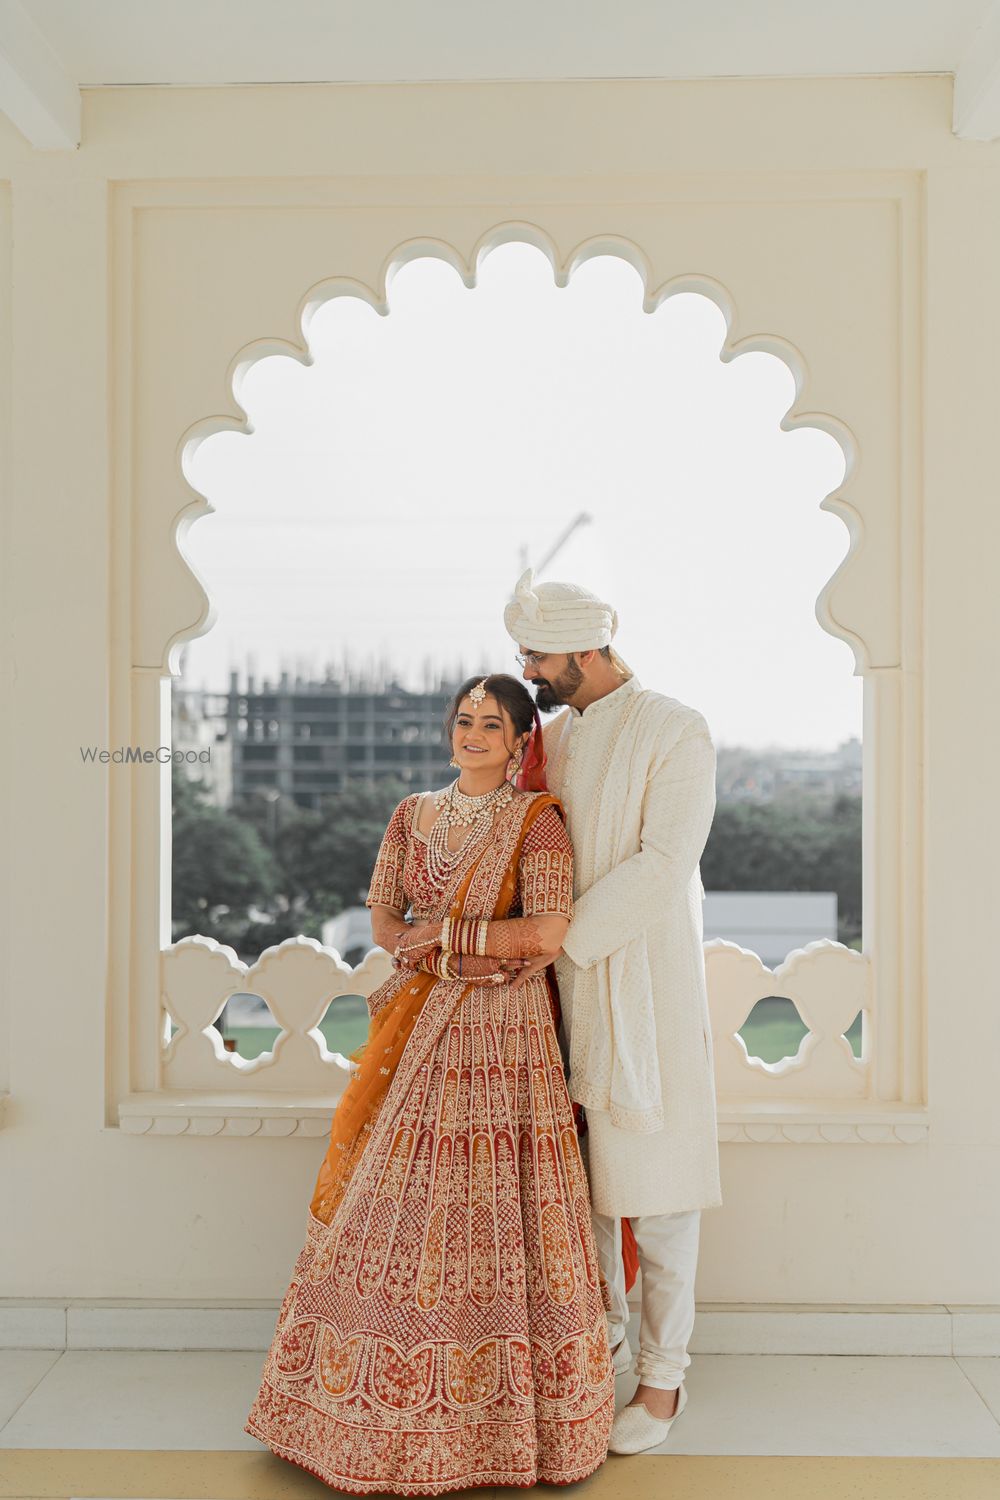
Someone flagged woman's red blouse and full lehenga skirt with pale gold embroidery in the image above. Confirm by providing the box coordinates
[247,794,613,1496]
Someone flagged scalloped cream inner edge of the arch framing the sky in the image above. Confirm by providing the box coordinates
[172,221,870,677]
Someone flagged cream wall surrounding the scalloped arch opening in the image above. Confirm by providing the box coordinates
[0,78,1000,1304]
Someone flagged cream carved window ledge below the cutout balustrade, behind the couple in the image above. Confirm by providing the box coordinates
[119,1092,930,1146]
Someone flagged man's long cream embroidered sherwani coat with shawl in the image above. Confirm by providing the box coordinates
[544,678,721,1218]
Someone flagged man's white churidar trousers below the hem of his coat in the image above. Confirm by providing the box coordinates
[594,1209,702,1391]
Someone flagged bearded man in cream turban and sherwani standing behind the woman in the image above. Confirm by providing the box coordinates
[504,570,721,1454]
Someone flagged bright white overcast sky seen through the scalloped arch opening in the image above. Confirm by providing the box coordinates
[184,245,861,747]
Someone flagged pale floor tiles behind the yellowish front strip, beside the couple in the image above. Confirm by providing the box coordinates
[0,1350,1000,1458]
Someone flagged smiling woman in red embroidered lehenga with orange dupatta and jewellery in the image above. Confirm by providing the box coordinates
[246,674,615,1496]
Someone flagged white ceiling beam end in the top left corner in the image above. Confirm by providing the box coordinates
[0,0,79,152]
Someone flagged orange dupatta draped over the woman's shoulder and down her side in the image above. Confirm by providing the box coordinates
[309,794,561,1224]
